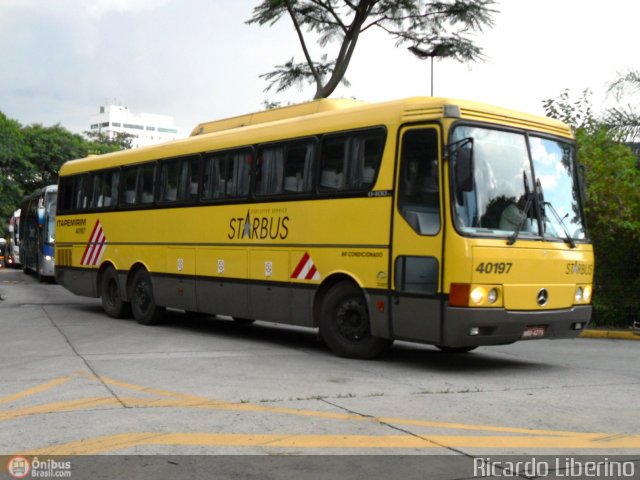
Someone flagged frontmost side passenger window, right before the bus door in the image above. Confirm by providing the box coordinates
[320,129,384,191]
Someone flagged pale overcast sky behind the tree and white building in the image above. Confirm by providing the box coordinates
[0,0,640,133]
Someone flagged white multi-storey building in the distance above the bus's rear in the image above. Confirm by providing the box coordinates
[91,105,183,148]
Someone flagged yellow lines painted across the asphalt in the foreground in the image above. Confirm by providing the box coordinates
[0,372,640,455]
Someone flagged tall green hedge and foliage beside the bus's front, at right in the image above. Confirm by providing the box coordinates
[543,90,640,325]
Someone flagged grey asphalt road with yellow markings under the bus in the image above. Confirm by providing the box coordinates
[0,270,640,478]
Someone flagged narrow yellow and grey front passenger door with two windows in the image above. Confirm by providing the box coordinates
[391,124,444,343]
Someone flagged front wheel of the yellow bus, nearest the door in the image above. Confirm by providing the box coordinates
[320,281,392,359]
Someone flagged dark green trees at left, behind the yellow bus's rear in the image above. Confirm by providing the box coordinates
[0,112,131,236]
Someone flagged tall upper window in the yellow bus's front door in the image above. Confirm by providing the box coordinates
[398,128,440,235]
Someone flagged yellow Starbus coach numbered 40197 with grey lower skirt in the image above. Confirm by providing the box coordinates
[56,97,594,358]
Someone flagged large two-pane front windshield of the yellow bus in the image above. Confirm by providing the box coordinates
[451,126,585,243]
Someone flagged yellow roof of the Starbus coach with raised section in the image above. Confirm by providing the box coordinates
[60,97,573,175]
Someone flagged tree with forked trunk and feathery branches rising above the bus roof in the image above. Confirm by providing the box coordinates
[247,0,496,99]
